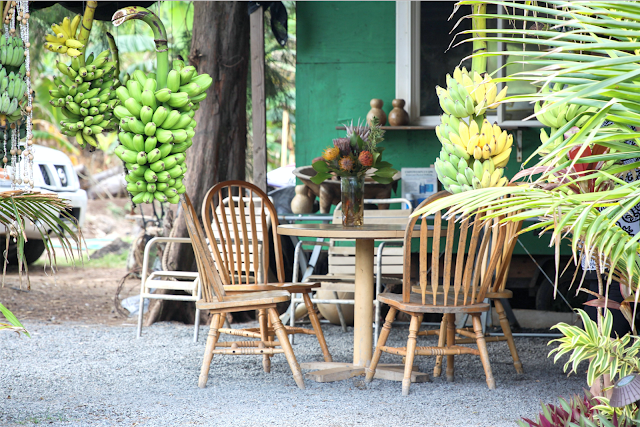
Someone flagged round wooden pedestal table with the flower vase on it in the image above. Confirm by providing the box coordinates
[278,224,428,382]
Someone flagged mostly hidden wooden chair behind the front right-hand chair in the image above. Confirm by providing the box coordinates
[411,203,523,377]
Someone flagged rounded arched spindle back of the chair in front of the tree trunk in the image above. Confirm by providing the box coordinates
[202,181,285,285]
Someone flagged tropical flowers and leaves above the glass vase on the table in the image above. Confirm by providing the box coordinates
[311,118,398,184]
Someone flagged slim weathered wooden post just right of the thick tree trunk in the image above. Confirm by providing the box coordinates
[250,7,267,191]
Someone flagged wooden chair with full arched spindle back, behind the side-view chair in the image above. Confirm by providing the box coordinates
[202,181,332,369]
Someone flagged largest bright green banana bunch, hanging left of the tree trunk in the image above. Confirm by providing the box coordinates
[113,61,211,204]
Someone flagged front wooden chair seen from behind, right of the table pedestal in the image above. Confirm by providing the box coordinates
[366,191,505,396]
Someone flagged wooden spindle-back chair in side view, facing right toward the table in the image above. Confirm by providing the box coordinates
[180,194,305,389]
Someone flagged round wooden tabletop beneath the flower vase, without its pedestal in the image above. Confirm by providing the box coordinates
[278,224,419,239]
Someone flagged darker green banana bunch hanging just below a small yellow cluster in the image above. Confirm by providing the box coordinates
[49,50,120,147]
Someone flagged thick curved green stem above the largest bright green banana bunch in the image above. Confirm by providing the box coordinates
[111,6,169,89]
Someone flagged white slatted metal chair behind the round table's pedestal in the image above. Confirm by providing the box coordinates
[289,198,412,344]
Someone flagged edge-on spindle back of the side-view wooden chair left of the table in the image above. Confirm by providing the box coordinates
[180,193,225,302]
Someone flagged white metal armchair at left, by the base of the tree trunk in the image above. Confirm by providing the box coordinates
[137,237,202,342]
